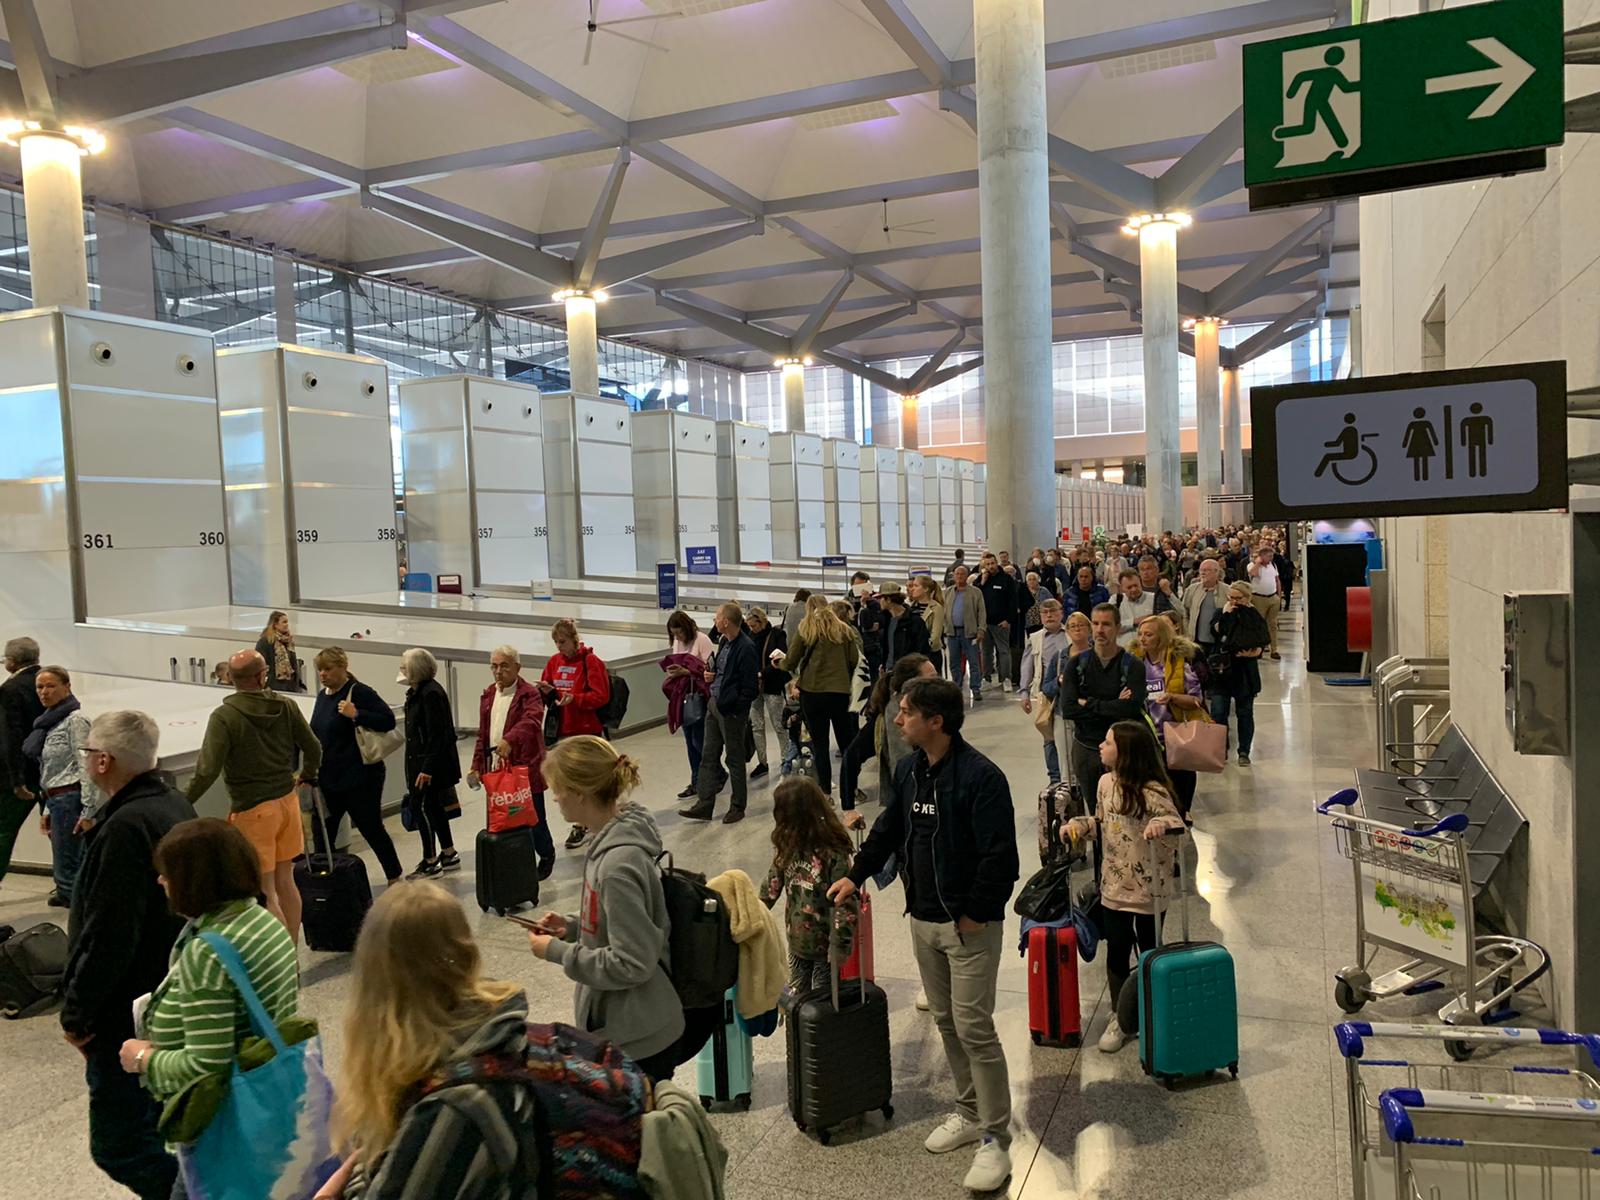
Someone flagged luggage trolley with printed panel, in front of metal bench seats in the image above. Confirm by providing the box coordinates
[1317,789,1550,1059]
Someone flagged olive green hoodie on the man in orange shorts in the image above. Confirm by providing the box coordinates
[189,688,322,813]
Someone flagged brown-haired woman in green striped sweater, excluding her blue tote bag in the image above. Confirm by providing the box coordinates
[122,818,299,1101]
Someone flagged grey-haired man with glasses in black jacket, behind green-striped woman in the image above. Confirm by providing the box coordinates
[61,712,195,1200]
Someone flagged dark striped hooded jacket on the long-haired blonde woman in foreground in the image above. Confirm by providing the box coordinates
[344,992,533,1200]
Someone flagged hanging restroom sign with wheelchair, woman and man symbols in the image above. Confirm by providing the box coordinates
[1250,362,1566,520]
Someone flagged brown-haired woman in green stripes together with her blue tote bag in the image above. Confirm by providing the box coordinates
[122,818,338,1200]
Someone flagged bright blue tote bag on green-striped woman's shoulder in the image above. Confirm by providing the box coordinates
[178,933,339,1200]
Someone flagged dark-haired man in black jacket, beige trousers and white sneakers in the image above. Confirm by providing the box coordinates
[829,678,1018,1192]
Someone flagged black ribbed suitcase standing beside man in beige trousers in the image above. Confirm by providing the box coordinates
[784,965,894,1146]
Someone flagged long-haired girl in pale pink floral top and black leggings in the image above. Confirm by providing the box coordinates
[1061,722,1184,1054]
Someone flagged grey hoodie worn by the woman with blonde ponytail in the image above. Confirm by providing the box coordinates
[549,803,683,1061]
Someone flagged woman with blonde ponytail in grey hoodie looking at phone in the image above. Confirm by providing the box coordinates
[528,736,683,1082]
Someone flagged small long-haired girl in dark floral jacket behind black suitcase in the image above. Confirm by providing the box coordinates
[762,776,859,994]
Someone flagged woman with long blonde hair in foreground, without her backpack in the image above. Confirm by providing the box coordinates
[328,882,538,1200]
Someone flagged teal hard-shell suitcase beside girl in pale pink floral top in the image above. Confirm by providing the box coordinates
[1136,842,1238,1088]
